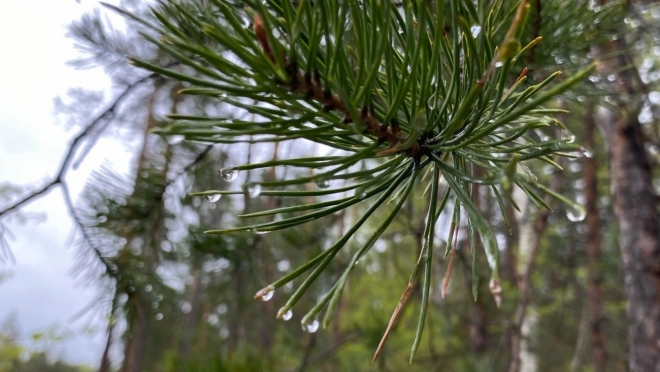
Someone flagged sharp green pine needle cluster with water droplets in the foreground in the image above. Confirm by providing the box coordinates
[114,0,595,358]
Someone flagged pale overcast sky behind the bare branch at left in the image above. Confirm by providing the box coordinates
[0,0,130,367]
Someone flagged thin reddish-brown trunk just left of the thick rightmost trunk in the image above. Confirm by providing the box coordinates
[582,104,607,372]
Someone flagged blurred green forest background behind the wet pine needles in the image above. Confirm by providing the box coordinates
[0,2,660,370]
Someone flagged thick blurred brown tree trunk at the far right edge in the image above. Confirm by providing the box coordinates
[600,25,660,372]
